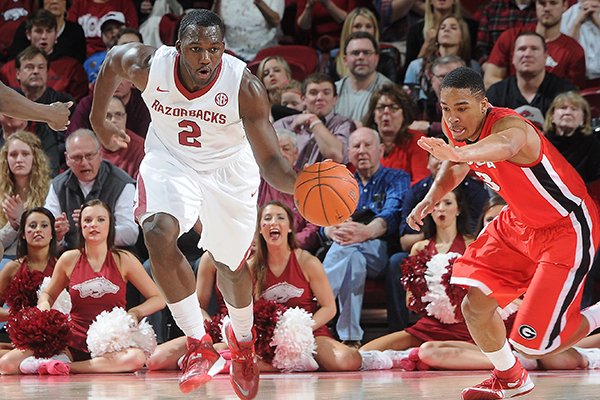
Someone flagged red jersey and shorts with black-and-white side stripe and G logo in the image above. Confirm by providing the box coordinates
[443,107,600,355]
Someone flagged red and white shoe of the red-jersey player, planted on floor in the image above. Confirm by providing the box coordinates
[461,360,535,400]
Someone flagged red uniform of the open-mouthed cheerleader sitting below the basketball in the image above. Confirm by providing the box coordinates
[262,251,333,338]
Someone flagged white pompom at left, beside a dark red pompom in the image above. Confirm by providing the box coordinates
[86,307,156,357]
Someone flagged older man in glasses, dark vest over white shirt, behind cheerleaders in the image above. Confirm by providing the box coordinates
[44,129,139,250]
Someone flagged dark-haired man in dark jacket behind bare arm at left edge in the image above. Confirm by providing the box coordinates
[15,46,73,176]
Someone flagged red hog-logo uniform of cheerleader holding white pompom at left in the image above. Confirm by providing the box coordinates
[67,250,127,361]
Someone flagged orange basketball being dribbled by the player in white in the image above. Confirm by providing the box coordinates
[294,161,359,226]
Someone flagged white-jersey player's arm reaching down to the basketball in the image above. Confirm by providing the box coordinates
[239,71,296,193]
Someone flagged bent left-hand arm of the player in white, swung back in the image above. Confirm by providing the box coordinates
[90,43,156,150]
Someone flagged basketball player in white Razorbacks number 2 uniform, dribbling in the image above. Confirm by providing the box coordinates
[90,9,296,399]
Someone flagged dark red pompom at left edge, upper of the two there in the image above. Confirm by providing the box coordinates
[4,268,44,314]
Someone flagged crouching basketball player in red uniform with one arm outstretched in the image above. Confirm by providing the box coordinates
[407,68,600,400]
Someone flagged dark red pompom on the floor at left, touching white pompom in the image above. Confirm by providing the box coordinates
[7,307,71,358]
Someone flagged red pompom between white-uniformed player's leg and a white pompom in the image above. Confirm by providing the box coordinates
[254,299,287,363]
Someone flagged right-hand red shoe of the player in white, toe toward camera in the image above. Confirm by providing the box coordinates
[224,322,259,400]
